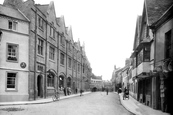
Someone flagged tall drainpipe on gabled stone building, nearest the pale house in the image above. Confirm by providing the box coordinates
[34,9,37,100]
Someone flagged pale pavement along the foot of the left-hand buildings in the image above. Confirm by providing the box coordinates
[0,92,91,106]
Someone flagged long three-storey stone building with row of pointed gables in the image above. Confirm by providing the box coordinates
[3,0,91,100]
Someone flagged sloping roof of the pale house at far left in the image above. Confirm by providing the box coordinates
[0,4,29,21]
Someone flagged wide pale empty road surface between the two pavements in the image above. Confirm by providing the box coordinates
[0,92,133,115]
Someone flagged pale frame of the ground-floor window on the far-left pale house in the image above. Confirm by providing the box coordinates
[5,71,18,92]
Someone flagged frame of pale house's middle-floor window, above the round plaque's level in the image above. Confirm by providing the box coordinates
[6,43,19,62]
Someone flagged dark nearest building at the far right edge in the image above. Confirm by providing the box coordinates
[149,0,173,113]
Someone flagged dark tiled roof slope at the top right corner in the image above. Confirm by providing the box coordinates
[145,0,173,25]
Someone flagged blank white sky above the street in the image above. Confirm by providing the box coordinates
[0,0,144,80]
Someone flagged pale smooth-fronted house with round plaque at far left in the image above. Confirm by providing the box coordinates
[0,5,30,102]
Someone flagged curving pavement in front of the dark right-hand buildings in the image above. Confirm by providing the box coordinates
[119,93,170,115]
